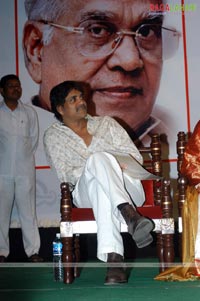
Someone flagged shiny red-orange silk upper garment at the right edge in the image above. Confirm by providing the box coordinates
[181,121,200,185]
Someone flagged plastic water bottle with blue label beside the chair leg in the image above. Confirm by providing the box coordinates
[53,233,63,281]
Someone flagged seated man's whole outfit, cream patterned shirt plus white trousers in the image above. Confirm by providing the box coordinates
[44,116,144,261]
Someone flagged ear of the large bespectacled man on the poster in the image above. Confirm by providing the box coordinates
[23,21,43,83]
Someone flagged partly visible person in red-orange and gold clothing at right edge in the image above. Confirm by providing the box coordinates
[155,121,200,281]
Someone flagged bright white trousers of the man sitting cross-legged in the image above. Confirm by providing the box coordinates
[73,152,144,262]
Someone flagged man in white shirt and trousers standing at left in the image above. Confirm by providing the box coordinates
[0,74,43,262]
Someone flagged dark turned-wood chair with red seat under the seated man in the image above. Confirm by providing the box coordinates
[60,134,174,284]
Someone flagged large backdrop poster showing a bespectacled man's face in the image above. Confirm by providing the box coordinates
[0,0,200,227]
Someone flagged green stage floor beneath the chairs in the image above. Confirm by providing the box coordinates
[0,258,200,301]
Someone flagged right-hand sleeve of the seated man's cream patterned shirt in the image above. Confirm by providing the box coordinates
[110,118,143,164]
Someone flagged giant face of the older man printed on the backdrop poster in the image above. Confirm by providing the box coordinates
[24,0,162,130]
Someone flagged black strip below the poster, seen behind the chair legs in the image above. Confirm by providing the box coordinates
[8,227,178,262]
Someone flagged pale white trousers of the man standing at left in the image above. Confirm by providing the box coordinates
[0,176,40,257]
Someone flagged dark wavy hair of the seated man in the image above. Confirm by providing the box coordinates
[50,81,86,121]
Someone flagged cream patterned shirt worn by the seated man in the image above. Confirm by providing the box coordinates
[44,115,143,184]
